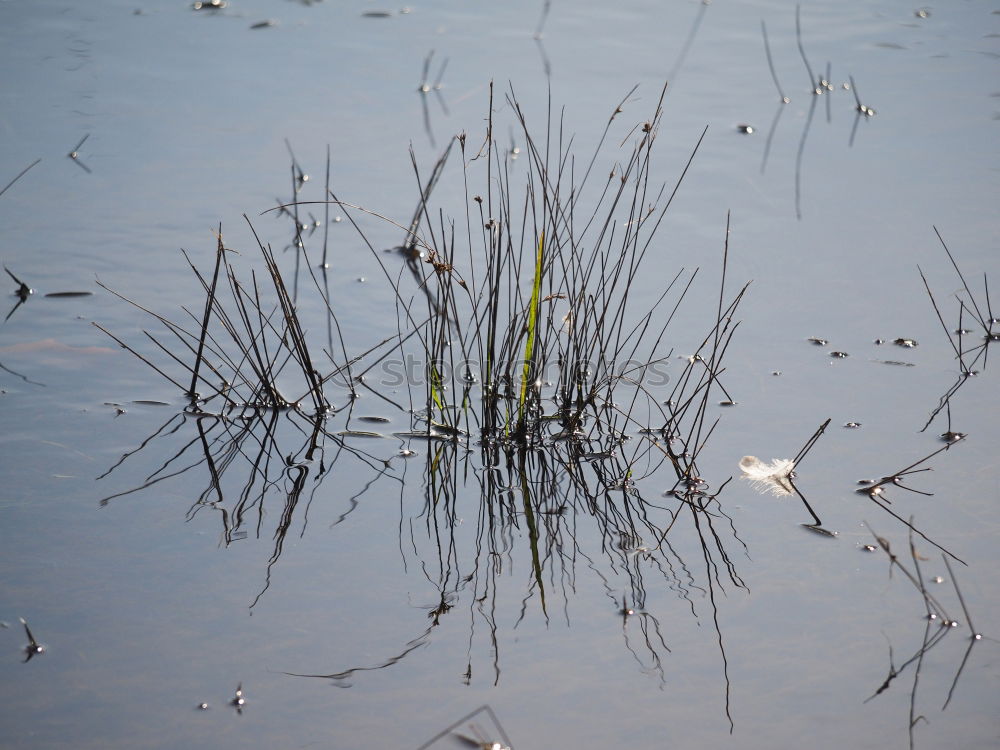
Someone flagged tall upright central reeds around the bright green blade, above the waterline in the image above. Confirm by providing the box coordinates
[326,81,704,446]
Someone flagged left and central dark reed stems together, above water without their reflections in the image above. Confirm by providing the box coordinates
[101,85,747,568]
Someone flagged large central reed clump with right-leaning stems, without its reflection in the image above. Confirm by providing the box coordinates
[331,87,742,470]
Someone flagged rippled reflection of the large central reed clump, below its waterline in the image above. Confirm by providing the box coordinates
[282,432,742,712]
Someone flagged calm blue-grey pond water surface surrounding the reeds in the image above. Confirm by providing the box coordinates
[0,0,1000,748]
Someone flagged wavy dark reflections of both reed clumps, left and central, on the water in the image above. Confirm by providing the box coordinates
[101,388,745,724]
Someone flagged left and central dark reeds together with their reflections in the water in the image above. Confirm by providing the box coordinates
[102,87,756,714]
